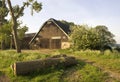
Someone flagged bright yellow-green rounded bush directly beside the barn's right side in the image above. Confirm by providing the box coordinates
[70,25,98,50]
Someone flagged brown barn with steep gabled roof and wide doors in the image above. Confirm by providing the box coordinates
[29,18,70,49]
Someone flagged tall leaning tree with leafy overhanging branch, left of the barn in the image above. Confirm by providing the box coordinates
[7,0,42,53]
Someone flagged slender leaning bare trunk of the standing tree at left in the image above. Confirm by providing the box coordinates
[7,0,21,53]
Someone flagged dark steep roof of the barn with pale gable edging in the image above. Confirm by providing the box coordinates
[29,18,71,44]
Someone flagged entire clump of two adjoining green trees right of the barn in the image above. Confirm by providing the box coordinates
[70,25,115,50]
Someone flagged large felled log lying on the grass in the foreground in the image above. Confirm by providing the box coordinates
[11,56,77,75]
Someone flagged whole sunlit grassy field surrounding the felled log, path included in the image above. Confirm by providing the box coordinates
[0,50,120,82]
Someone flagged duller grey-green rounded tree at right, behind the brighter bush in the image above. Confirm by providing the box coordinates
[95,25,116,49]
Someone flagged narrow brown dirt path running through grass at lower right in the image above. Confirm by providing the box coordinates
[79,58,120,80]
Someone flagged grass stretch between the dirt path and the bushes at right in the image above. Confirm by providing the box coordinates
[71,50,120,73]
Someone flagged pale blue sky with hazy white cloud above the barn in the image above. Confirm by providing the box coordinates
[11,0,120,43]
